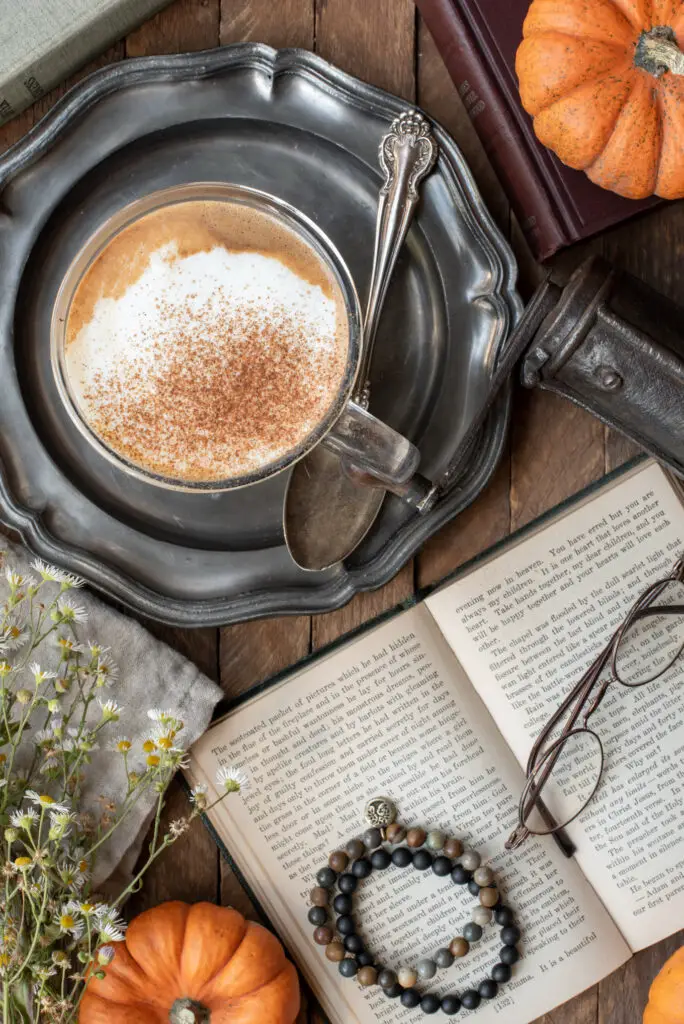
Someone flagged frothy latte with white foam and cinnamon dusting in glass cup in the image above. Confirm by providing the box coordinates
[63,200,349,484]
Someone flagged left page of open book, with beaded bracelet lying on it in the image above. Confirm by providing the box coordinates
[190,607,629,1024]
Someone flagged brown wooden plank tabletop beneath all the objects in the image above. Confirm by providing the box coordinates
[0,0,684,1024]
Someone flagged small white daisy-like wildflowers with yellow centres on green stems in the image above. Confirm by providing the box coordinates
[0,560,247,1024]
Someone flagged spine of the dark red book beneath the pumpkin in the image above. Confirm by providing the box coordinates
[416,0,565,259]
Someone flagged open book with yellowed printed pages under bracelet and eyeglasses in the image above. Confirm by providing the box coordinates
[188,462,684,1024]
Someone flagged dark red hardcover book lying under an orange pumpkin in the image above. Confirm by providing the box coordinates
[416,0,659,259]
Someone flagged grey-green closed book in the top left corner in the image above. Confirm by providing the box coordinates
[0,0,169,124]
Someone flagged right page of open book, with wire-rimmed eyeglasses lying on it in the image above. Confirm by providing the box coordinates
[427,463,684,950]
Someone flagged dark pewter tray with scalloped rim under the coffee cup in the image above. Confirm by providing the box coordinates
[0,44,520,626]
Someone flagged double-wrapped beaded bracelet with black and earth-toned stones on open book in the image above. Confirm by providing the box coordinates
[308,798,520,1016]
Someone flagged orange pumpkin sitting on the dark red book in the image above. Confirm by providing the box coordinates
[516,0,684,199]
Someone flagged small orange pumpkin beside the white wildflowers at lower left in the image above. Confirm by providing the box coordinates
[79,902,299,1024]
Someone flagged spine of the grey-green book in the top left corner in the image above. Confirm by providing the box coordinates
[0,0,170,125]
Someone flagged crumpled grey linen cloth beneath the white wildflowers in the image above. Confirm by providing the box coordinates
[0,538,222,889]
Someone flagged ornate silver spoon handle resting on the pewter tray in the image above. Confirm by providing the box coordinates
[354,111,437,409]
